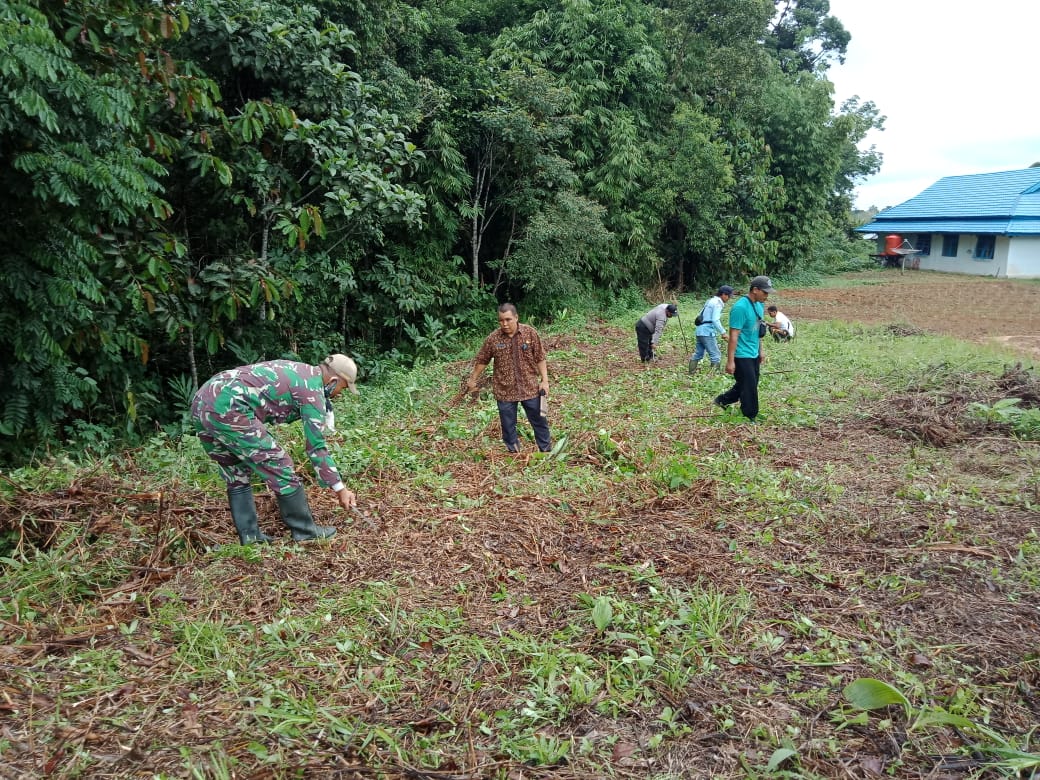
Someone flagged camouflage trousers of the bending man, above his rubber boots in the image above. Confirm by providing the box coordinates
[191,398,302,495]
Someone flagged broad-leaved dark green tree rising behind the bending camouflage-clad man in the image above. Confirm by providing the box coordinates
[162,0,423,364]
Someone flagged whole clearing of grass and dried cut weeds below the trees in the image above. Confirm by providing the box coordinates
[0,271,1040,780]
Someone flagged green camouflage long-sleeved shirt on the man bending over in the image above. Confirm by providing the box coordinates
[194,360,341,488]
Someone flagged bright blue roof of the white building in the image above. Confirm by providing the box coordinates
[856,167,1040,235]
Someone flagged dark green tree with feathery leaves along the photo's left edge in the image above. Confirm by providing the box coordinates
[0,0,214,448]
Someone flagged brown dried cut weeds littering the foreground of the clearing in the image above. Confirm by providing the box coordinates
[0,272,1040,780]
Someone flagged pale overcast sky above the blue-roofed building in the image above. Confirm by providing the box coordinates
[827,0,1040,209]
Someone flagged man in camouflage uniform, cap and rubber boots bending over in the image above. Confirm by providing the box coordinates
[191,355,358,544]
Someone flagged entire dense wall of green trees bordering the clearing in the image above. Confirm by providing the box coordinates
[0,0,881,459]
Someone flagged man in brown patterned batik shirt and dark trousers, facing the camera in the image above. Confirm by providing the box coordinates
[466,304,552,452]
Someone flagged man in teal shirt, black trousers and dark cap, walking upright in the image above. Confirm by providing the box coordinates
[714,277,773,421]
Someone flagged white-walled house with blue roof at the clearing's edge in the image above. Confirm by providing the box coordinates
[856,167,1040,279]
